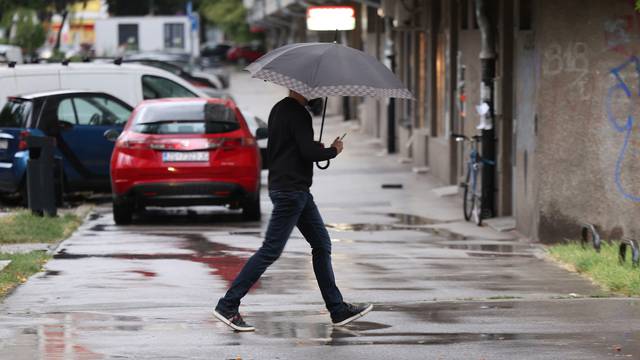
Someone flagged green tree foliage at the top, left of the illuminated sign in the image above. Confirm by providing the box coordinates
[200,0,260,43]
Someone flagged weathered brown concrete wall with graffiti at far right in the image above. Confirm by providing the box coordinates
[531,0,640,242]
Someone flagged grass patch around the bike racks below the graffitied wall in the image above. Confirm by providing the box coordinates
[549,243,640,296]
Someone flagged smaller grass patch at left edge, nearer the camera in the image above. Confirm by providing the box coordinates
[0,251,50,299]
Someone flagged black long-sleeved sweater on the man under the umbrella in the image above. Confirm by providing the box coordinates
[267,97,338,191]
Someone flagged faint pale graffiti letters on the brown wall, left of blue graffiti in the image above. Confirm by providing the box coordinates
[542,42,591,100]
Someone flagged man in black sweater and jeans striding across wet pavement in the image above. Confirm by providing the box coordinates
[213,90,373,331]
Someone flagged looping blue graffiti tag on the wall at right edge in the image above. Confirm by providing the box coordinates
[605,56,640,202]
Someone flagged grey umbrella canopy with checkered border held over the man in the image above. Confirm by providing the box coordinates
[245,43,413,99]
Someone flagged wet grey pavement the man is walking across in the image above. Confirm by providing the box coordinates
[0,71,640,359]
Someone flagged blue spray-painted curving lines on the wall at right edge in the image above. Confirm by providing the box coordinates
[606,56,640,202]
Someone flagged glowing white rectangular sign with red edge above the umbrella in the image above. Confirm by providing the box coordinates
[307,6,356,31]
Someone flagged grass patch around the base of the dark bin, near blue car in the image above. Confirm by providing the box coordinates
[0,211,81,244]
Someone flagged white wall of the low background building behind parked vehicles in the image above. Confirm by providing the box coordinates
[95,16,200,56]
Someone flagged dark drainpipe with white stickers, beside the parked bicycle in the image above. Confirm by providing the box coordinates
[475,0,496,217]
